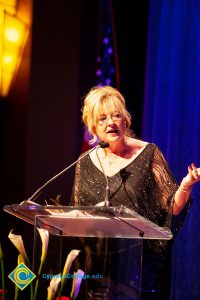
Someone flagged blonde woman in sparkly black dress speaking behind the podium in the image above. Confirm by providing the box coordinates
[72,86,200,299]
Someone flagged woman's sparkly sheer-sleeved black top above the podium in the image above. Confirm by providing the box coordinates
[72,144,178,226]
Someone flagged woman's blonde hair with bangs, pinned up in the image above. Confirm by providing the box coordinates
[82,85,131,144]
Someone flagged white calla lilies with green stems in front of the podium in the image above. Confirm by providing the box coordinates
[0,228,84,300]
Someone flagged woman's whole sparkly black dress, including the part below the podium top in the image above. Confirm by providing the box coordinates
[71,143,183,299]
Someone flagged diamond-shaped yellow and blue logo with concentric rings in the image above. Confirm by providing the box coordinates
[8,263,36,290]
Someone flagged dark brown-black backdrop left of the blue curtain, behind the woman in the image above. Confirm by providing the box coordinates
[0,0,149,296]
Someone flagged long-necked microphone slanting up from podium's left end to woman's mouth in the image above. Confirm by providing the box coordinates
[20,141,109,205]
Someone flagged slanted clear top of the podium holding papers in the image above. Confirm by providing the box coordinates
[4,201,172,240]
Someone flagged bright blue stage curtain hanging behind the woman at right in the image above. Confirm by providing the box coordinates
[142,0,200,300]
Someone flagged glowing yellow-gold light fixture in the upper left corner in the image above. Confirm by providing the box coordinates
[0,0,28,97]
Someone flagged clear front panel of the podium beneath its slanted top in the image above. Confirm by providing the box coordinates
[33,223,143,300]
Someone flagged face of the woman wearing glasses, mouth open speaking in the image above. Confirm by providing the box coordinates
[96,110,126,144]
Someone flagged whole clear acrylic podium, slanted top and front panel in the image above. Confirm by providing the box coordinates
[4,201,172,300]
